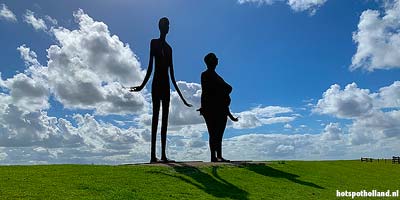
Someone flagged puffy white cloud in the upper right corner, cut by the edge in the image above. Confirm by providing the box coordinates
[350,0,400,71]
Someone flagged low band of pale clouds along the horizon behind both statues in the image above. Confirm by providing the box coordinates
[0,103,400,164]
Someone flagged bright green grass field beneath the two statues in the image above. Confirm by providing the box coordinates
[0,161,400,199]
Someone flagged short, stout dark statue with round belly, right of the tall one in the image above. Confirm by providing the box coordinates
[198,53,238,162]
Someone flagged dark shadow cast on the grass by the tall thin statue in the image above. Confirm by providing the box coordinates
[153,164,249,200]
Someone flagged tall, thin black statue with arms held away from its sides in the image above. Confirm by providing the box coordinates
[130,17,192,162]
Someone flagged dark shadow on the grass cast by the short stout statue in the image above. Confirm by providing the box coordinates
[243,164,325,189]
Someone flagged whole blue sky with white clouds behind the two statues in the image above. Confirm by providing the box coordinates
[0,0,400,164]
